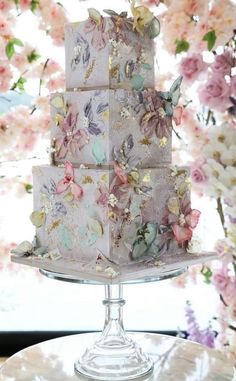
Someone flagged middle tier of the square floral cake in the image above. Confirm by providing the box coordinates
[51,89,172,168]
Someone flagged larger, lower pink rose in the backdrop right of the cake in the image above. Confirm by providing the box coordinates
[199,75,230,111]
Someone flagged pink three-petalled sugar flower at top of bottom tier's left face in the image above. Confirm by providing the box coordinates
[56,161,83,199]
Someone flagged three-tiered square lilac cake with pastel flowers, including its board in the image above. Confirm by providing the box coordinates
[12,9,214,282]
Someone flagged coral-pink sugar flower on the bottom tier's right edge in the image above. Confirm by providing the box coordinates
[168,193,201,244]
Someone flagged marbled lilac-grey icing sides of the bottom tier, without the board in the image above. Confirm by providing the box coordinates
[30,166,190,272]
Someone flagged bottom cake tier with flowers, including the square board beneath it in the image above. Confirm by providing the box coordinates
[12,162,216,282]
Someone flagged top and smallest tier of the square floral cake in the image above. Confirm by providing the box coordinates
[65,14,155,90]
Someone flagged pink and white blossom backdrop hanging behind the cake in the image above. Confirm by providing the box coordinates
[0,0,236,362]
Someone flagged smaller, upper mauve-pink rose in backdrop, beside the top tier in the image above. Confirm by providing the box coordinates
[179,53,207,82]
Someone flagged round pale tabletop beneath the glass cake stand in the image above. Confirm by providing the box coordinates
[0,333,236,381]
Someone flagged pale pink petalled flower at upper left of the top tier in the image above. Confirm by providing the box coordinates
[84,17,108,50]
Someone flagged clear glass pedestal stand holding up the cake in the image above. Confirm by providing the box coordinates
[39,268,186,381]
